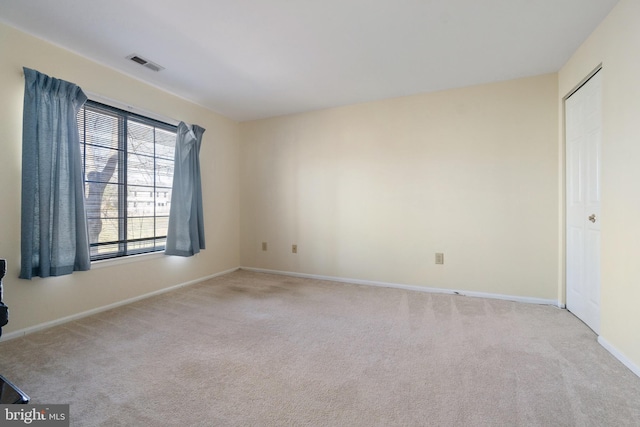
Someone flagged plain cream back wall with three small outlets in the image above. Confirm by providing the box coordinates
[240,74,560,301]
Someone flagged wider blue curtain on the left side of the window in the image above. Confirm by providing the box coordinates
[20,68,91,279]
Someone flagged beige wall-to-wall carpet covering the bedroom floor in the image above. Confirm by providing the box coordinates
[0,271,640,426]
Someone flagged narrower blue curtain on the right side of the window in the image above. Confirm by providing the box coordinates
[165,122,205,256]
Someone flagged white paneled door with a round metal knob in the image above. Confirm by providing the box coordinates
[565,71,602,334]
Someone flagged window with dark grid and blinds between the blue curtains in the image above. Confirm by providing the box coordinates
[78,101,176,261]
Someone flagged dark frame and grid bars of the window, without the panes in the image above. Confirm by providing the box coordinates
[77,99,178,263]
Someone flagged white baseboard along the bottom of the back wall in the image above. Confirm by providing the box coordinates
[240,267,561,307]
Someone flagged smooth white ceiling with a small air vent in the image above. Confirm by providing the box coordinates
[0,0,618,121]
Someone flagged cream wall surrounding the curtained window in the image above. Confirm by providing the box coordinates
[0,24,239,334]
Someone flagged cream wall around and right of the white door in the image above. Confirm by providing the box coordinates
[559,0,640,375]
